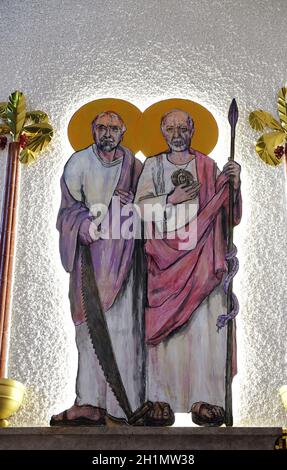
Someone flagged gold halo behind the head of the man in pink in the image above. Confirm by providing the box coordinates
[140,98,218,157]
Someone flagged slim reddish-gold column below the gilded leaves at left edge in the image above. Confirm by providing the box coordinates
[0,142,20,378]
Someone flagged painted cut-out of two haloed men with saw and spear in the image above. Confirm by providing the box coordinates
[50,99,242,426]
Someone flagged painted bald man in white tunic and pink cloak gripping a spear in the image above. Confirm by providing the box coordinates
[135,110,241,425]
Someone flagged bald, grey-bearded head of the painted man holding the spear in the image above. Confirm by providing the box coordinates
[162,111,193,152]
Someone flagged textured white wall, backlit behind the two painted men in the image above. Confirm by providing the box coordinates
[0,0,287,426]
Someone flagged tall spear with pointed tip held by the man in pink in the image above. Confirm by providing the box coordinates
[225,98,238,426]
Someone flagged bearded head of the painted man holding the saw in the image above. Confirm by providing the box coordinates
[93,114,123,152]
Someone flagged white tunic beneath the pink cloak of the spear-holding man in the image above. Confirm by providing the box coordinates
[136,154,226,413]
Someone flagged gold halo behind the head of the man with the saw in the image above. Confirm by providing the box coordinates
[68,98,142,153]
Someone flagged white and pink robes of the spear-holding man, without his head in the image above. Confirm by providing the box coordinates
[136,151,241,412]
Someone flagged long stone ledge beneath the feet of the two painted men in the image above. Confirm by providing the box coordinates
[0,426,282,450]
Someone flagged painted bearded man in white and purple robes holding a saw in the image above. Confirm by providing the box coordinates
[50,111,144,426]
